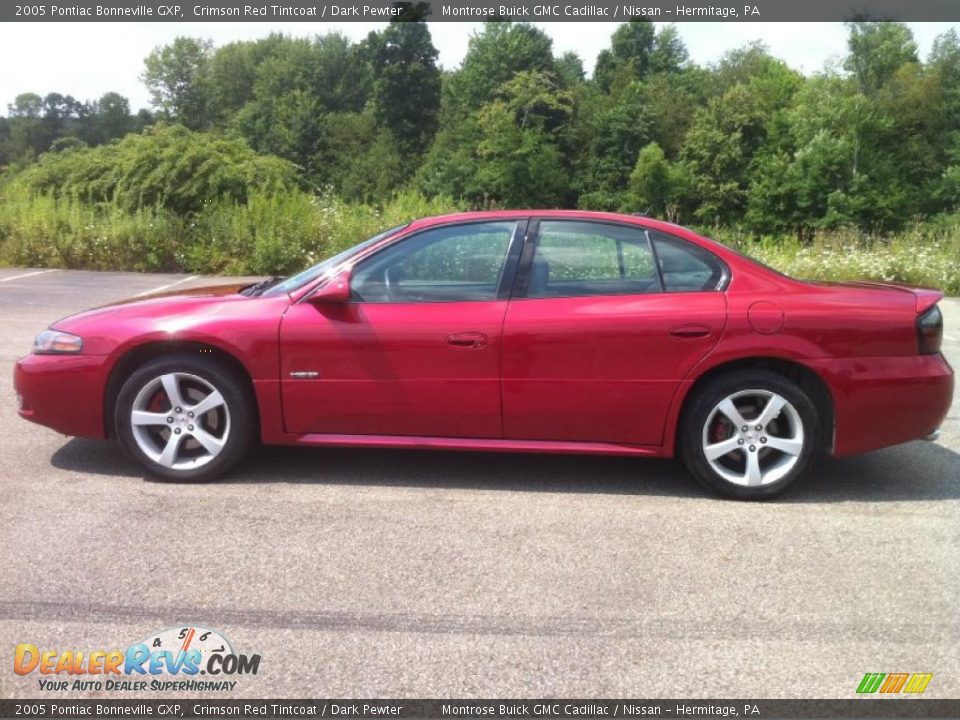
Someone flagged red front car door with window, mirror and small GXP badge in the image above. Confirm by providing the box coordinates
[280,219,526,438]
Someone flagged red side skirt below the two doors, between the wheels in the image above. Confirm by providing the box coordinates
[274,433,663,457]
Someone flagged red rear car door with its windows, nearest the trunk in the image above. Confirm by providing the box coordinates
[503,219,726,445]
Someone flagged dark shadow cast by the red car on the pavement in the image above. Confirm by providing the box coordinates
[51,438,960,503]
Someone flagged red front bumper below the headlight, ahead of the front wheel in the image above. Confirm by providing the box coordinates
[13,355,106,438]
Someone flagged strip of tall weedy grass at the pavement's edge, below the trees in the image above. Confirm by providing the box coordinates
[0,183,960,295]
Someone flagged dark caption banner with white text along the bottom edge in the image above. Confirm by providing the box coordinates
[0,698,960,719]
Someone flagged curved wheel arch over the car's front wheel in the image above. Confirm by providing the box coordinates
[103,340,260,438]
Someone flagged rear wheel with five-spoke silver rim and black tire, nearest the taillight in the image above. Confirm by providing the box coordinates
[680,370,820,500]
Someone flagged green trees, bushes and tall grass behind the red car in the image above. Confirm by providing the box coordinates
[0,18,960,292]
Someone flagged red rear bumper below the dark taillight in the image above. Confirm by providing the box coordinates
[809,354,954,456]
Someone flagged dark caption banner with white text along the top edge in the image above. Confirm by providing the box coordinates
[0,0,960,22]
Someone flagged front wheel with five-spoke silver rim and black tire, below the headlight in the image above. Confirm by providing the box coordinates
[115,355,255,481]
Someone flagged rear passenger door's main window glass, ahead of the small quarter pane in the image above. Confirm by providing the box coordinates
[527,220,660,298]
